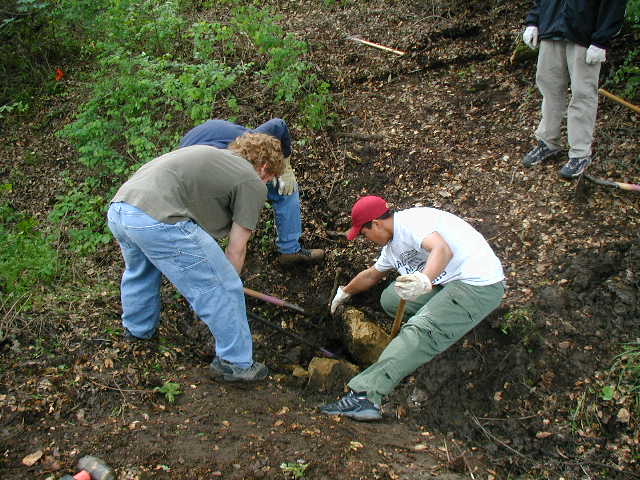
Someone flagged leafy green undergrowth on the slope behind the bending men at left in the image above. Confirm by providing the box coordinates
[0,0,332,295]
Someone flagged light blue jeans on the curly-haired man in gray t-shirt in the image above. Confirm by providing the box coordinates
[107,202,253,368]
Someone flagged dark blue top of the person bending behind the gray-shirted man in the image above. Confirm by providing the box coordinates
[180,118,291,158]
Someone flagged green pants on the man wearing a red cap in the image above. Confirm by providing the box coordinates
[349,281,504,405]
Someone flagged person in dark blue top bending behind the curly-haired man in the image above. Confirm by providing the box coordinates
[180,118,324,265]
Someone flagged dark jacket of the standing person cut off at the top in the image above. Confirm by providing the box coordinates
[525,0,627,49]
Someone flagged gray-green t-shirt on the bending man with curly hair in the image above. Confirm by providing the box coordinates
[111,145,267,238]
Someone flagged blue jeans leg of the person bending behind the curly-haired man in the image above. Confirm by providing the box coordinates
[267,182,302,253]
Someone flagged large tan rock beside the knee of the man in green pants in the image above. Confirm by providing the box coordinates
[342,308,391,365]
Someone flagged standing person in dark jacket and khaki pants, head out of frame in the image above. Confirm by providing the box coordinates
[522,0,627,179]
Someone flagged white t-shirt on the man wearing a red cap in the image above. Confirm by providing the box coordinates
[373,207,504,286]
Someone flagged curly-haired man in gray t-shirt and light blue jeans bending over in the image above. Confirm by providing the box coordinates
[108,134,283,381]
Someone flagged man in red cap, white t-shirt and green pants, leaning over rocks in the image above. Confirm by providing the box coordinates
[320,195,504,421]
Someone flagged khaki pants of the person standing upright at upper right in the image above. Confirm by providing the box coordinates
[535,40,600,158]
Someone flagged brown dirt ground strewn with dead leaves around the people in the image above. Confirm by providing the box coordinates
[0,0,640,479]
